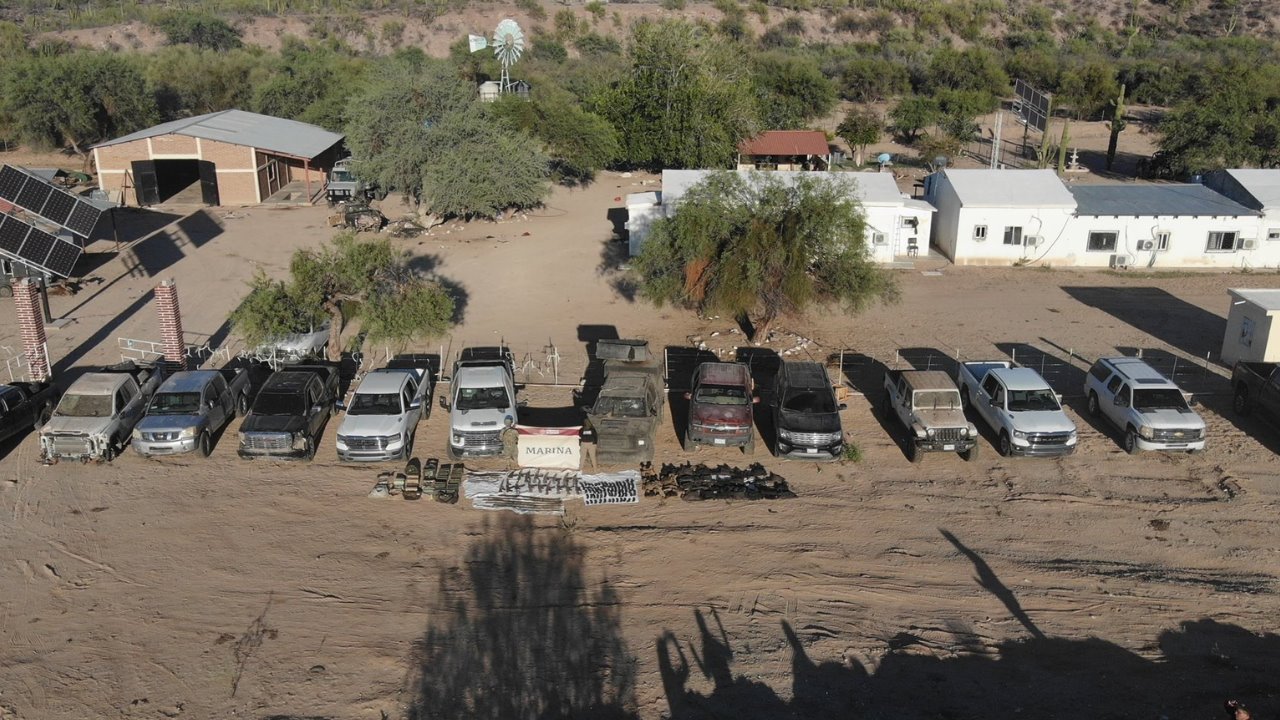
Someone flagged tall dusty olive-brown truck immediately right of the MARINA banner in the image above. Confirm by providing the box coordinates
[586,340,666,465]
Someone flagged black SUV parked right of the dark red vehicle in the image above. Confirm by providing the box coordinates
[773,361,845,460]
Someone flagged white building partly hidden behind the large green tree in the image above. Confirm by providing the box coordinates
[626,170,934,263]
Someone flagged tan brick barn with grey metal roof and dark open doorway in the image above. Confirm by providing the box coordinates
[93,110,343,206]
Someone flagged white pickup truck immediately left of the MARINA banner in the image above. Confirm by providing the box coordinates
[440,346,520,460]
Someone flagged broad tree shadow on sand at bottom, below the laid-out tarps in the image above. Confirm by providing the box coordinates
[408,514,636,720]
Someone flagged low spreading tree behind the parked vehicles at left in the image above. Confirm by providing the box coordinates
[230,233,454,359]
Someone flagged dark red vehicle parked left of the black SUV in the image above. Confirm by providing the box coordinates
[685,363,760,455]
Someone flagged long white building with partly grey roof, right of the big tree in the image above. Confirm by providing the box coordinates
[925,169,1280,268]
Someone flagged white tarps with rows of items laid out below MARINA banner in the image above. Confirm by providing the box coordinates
[462,469,640,515]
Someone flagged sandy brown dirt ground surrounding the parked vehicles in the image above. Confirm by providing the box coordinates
[0,156,1280,720]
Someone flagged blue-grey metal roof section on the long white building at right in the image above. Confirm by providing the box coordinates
[1070,183,1258,218]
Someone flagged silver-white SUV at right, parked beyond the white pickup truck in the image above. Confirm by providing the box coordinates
[1084,357,1204,454]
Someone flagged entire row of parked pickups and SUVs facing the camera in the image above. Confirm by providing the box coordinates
[15,340,1239,464]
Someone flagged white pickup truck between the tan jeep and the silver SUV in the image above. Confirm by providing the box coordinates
[957,361,1078,456]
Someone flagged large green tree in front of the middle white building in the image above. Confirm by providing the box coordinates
[635,170,897,336]
